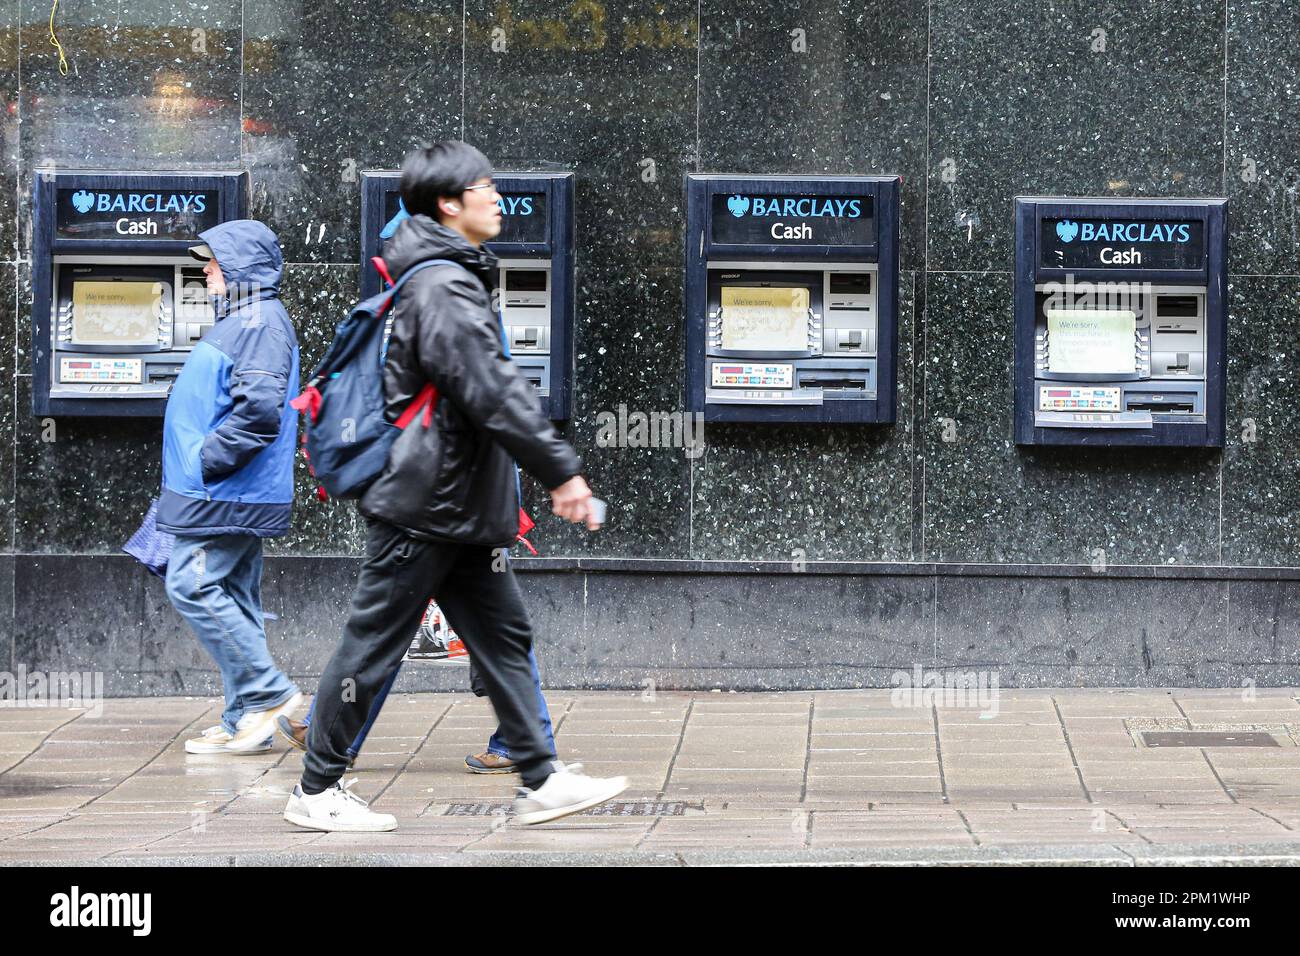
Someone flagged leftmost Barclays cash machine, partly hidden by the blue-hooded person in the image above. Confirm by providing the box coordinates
[31,168,248,416]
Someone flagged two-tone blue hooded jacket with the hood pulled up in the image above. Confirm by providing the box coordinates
[157,220,298,537]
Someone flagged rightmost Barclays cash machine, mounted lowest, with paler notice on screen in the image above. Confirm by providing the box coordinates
[1015,198,1227,447]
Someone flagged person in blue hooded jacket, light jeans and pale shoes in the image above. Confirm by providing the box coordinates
[157,220,303,753]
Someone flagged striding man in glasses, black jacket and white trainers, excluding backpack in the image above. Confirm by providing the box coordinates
[285,142,627,831]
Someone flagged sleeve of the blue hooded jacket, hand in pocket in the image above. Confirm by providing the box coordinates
[199,316,294,484]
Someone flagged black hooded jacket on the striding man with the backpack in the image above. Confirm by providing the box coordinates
[359,216,582,546]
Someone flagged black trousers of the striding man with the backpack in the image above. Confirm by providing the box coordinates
[303,519,553,793]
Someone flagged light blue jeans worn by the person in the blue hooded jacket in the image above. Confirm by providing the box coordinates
[166,535,298,734]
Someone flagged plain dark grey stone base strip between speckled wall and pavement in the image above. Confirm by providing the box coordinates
[10,554,1300,696]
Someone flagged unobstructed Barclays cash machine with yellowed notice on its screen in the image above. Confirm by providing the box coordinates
[686,174,901,423]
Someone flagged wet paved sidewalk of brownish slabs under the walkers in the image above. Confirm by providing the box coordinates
[0,689,1300,865]
